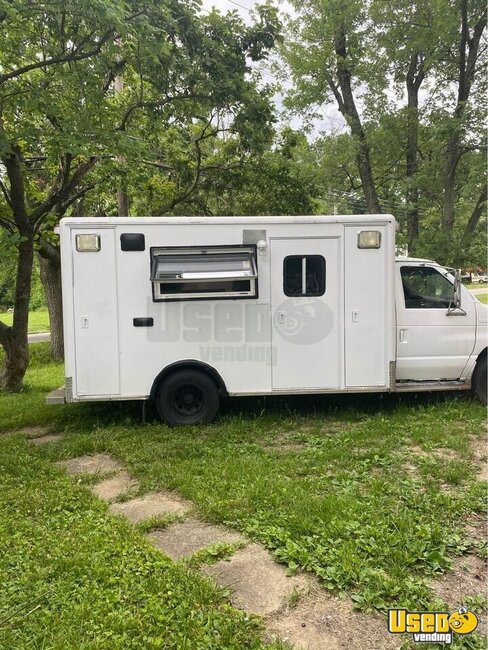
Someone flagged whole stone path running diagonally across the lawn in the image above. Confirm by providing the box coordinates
[47,448,402,650]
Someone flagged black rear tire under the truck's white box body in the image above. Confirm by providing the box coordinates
[156,370,219,427]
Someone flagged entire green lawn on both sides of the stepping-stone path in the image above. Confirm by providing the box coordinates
[0,344,486,648]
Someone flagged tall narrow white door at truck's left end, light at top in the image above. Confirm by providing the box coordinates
[71,228,120,397]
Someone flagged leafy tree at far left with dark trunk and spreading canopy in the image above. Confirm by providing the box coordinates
[0,0,278,390]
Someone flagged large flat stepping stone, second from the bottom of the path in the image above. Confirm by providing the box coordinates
[204,544,309,616]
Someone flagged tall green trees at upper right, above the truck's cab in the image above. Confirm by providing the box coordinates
[282,0,486,266]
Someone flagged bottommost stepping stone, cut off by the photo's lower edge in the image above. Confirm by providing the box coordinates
[266,590,405,650]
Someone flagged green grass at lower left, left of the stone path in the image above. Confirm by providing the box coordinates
[0,436,274,650]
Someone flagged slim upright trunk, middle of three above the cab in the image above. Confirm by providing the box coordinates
[405,52,425,251]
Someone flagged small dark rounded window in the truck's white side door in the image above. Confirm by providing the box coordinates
[283,255,325,297]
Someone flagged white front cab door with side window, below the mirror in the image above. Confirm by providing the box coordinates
[396,262,476,381]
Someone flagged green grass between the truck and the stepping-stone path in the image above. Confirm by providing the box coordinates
[0,344,485,647]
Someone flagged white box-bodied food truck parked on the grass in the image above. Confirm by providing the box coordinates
[48,214,488,425]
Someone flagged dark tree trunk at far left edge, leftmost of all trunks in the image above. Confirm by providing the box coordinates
[0,236,34,393]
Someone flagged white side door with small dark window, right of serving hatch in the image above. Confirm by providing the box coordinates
[270,237,342,391]
